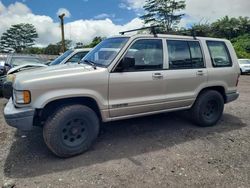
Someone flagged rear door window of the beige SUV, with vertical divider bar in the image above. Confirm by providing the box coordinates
[167,40,204,69]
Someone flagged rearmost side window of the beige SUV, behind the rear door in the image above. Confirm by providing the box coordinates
[207,41,232,67]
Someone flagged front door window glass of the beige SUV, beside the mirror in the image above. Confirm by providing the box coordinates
[118,39,163,71]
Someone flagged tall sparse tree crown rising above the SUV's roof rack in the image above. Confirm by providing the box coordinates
[141,0,186,32]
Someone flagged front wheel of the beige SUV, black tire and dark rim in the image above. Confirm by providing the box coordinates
[43,105,99,158]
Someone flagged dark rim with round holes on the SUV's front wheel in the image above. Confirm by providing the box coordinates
[61,118,88,147]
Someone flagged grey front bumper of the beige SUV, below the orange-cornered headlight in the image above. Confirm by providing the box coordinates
[4,99,35,131]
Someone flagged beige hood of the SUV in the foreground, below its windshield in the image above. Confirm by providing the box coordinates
[14,64,104,89]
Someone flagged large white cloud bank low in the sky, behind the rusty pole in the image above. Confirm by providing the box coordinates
[0,1,143,46]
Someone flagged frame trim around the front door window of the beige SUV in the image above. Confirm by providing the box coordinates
[111,37,167,73]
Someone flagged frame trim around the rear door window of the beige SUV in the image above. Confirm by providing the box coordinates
[166,39,207,70]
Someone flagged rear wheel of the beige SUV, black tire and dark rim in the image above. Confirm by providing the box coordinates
[191,90,224,127]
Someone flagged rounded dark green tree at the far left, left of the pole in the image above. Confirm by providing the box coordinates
[0,23,38,52]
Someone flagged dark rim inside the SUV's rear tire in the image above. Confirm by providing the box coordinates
[203,100,219,120]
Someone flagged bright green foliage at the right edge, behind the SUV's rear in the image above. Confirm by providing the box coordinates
[232,34,250,59]
